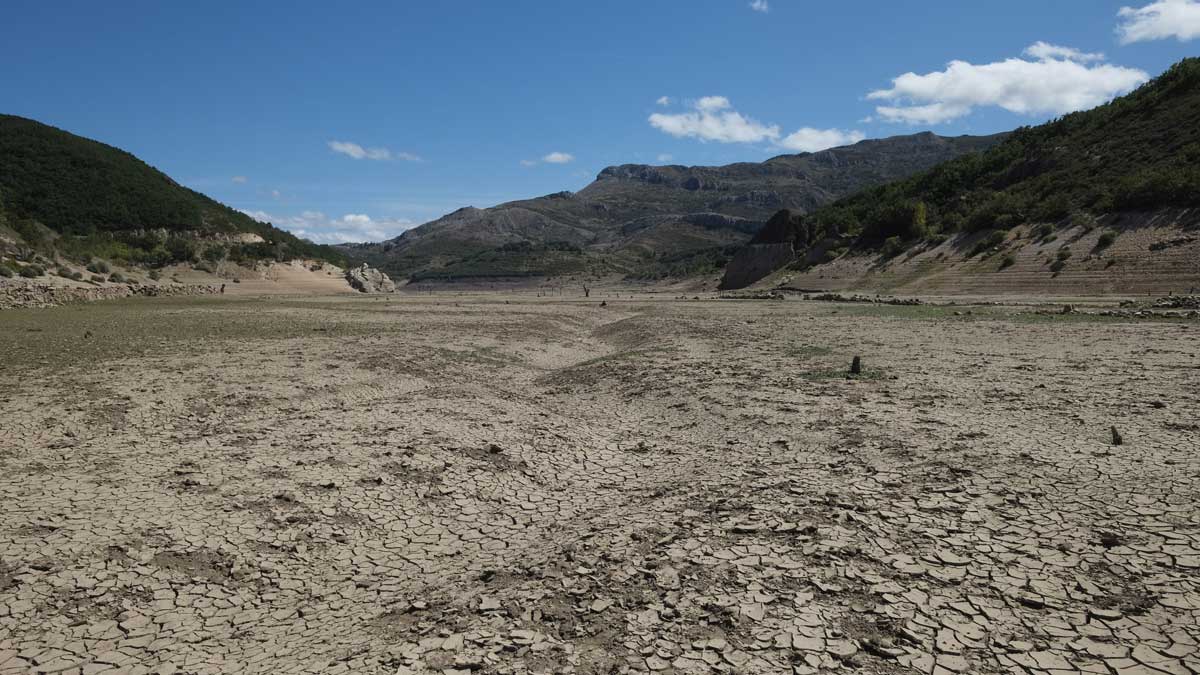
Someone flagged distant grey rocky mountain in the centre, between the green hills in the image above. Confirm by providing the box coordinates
[347,133,1003,280]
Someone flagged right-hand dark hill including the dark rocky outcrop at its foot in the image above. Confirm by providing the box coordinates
[722,58,1200,288]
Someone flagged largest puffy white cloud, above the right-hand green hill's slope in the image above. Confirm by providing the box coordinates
[866,42,1150,124]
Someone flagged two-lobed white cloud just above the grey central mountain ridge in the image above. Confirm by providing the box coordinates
[649,96,865,153]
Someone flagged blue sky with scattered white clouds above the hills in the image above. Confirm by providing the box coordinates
[0,0,1200,241]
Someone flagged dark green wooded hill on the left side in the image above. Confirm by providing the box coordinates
[0,115,344,263]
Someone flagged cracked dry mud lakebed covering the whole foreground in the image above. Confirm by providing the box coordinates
[0,294,1200,675]
